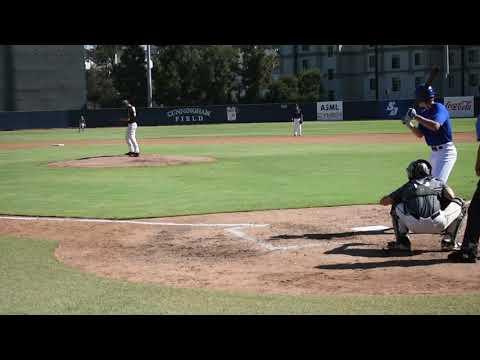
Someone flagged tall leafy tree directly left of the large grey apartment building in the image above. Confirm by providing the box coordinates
[235,45,278,103]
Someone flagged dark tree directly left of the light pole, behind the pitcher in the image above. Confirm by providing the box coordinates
[112,45,147,107]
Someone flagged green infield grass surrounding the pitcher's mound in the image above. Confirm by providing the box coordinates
[0,130,476,218]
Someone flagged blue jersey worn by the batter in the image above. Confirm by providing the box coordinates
[418,103,452,146]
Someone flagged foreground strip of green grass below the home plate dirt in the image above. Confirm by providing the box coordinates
[0,237,480,314]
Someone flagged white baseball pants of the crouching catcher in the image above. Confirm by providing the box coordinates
[395,202,462,234]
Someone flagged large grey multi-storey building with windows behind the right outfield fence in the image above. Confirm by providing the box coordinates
[274,45,480,101]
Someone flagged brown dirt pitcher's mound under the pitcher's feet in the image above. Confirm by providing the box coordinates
[48,154,215,168]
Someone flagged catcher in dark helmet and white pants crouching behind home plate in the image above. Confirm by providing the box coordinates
[380,159,466,251]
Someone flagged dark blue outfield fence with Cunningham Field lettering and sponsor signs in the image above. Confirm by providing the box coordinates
[0,97,480,130]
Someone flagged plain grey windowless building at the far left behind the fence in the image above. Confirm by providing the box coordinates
[0,45,87,111]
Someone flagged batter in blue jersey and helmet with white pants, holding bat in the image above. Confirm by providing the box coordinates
[403,84,457,183]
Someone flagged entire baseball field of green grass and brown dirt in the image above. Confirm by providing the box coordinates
[0,119,480,314]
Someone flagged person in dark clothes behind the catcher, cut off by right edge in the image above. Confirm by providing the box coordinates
[448,115,480,263]
